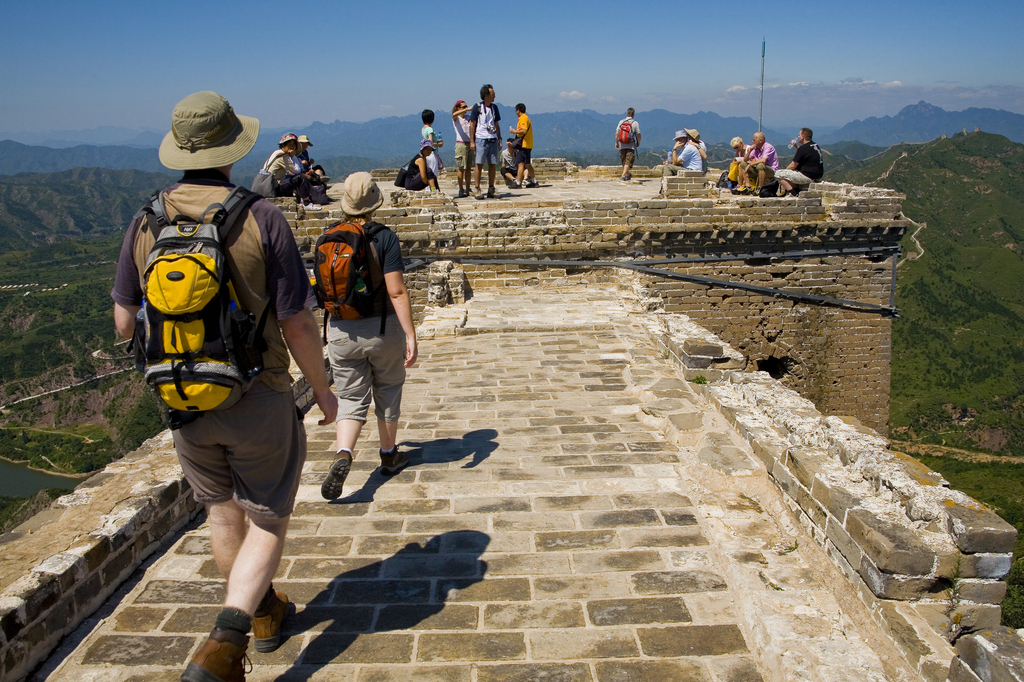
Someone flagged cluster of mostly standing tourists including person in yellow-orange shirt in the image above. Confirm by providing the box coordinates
[401,84,538,199]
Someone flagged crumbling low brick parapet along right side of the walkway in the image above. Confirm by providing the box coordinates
[636,309,1024,682]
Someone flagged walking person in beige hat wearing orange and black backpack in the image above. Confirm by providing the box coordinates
[314,173,418,500]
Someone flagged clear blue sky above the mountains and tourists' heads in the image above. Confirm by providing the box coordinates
[0,0,1024,132]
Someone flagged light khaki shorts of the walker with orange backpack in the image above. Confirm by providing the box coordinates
[327,314,406,422]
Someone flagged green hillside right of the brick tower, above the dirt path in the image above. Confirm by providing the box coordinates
[828,132,1024,456]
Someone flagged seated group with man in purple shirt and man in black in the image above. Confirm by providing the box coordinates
[728,128,824,197]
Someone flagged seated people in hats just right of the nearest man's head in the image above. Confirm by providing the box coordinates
[253,133,331,210]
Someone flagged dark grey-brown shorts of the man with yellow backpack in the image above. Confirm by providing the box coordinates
[172,381,306,520]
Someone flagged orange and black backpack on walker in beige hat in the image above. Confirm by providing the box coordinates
[313,222,387,337]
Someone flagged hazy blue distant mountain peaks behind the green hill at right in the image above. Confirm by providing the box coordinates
[817,100,1024,146]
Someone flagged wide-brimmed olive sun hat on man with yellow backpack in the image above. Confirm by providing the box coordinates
[160,90,259,170]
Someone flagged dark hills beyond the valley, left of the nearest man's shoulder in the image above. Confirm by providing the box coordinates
[0,168,176,253]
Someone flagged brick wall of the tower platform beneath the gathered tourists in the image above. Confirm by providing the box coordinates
[286,183,909,432]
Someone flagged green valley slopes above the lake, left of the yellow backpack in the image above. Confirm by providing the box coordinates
[0,232,162,472]
